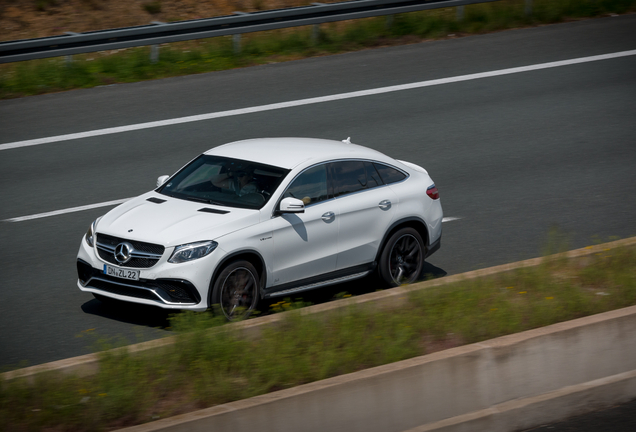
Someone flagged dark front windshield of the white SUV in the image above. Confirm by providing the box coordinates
[157,155,289,209]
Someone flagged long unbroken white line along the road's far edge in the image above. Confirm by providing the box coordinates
[0,50,636,150]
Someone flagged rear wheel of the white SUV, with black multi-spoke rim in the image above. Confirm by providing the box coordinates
[379,228,424,287]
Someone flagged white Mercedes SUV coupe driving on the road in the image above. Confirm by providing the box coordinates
[77,138,442,319]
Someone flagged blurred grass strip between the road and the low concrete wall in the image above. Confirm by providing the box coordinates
[0,243,636,431]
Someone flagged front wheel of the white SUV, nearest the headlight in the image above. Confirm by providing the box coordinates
[211,260,260,321]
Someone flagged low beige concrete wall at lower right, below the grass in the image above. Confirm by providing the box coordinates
[113,306,636,432]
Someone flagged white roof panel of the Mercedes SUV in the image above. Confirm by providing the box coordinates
[205,138,394,169]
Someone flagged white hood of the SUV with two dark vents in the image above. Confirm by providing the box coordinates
[96,192,260,247]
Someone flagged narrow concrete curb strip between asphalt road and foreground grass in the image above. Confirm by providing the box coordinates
[1,237,636,380]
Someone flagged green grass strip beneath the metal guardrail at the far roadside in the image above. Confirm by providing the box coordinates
[0,0,636,99]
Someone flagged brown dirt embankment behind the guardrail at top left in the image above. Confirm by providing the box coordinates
[0,0,318,41]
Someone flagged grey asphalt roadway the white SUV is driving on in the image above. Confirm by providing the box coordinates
[0,15,636,368]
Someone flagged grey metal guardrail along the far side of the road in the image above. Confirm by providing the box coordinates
[0,0,506,63]
